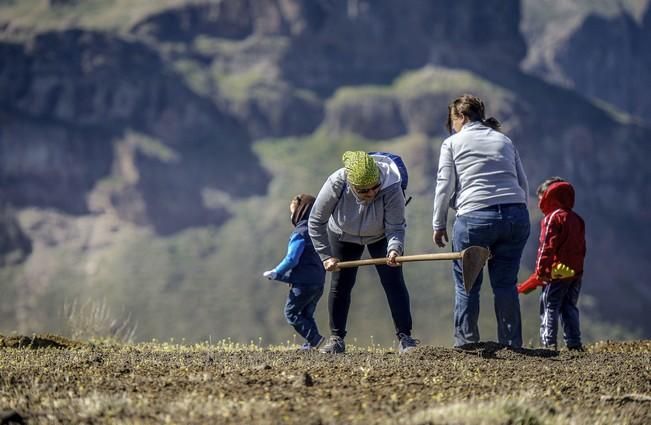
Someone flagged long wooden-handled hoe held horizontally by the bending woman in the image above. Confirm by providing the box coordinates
[337,246,490,293]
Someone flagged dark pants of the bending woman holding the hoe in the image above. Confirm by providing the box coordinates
[328,233,411,338]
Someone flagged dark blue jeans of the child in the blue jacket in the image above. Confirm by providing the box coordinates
[285,285,323,346]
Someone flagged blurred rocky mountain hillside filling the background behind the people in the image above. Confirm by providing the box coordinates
[0,0,651,345]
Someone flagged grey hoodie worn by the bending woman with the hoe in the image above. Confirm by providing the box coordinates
[308,162,407,261]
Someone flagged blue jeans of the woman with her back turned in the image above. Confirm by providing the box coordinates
[452,204,530,347]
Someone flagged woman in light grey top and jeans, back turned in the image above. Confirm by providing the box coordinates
[432,94,529,347]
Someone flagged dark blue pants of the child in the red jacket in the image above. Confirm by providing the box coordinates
[540,278,581,347]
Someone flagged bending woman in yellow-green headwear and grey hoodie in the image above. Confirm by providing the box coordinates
[308,151,418,354]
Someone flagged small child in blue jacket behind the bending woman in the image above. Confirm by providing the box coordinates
[263,193,325,349]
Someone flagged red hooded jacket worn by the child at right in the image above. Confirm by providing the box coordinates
[534,182,586,282]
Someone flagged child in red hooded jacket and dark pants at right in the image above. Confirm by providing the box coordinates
[518,177,586,350]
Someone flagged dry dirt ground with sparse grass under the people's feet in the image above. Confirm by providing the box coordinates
[0,335,651,425]
